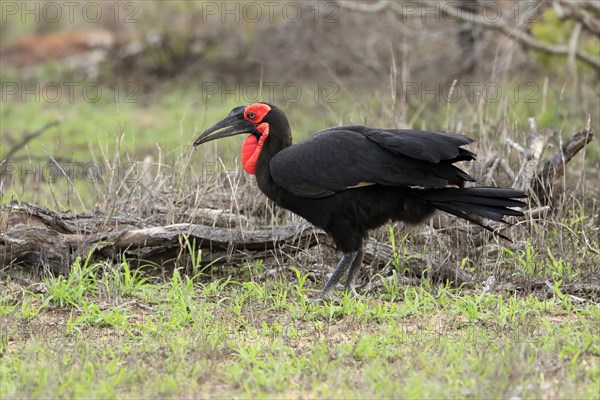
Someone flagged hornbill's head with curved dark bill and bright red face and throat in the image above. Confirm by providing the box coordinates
[194,103,291,174]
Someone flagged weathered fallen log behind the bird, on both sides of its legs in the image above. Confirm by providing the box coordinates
[0,204,472,285]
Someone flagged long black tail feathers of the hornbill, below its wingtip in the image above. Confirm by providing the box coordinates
[421,187,527,240]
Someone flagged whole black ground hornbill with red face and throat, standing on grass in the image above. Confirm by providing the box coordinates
[194,103,526,299]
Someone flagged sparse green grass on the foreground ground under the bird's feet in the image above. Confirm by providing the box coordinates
[0,264,600,399]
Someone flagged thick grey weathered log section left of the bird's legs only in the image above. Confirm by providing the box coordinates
[0,204,324,274]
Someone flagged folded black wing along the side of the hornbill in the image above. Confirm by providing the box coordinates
[270,126,473,198]
